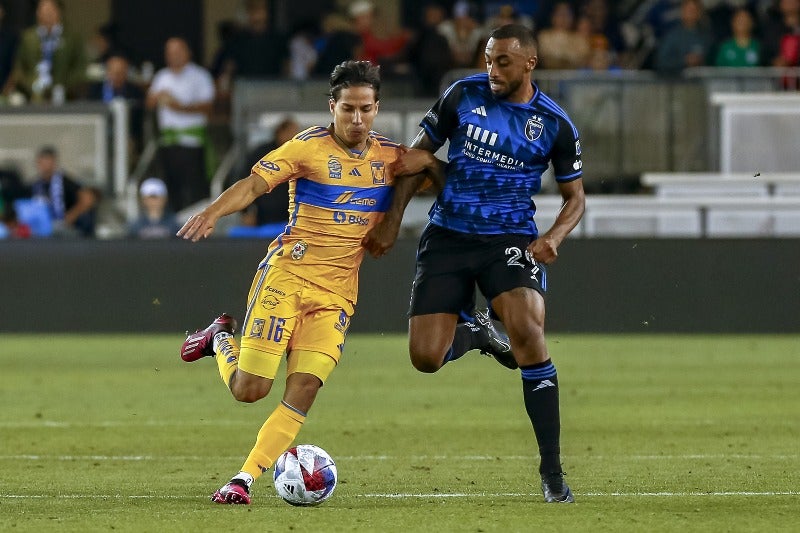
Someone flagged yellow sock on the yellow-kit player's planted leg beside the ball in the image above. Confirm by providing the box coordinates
[242,402,306,479]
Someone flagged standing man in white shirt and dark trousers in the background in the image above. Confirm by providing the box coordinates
[145,37,214,212]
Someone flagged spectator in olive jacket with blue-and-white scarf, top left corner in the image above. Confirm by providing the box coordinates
[9,0,86,101]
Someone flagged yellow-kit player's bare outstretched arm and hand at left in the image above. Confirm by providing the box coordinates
[177,174,267,242]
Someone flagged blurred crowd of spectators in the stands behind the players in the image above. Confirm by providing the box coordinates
[0,0,800,238]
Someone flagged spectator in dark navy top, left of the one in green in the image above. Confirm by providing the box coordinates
[655,0,714,76]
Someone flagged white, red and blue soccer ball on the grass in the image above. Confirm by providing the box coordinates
[275,444,337,506]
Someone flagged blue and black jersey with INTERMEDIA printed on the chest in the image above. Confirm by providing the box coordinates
[420,74,582,238]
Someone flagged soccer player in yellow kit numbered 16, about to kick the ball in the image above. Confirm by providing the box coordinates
[178,61,402,504]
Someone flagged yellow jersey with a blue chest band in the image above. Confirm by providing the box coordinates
[252,122,400,304]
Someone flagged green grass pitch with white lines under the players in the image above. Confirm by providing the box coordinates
[0,334,800,533]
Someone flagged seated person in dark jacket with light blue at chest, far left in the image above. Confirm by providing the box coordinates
[28,146,99,237]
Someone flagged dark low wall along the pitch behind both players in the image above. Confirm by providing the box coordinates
[0,239,800,334]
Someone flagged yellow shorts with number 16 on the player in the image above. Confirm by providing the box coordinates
[239,266,354,383]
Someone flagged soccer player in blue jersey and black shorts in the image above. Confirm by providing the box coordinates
[363,24,585,503]
